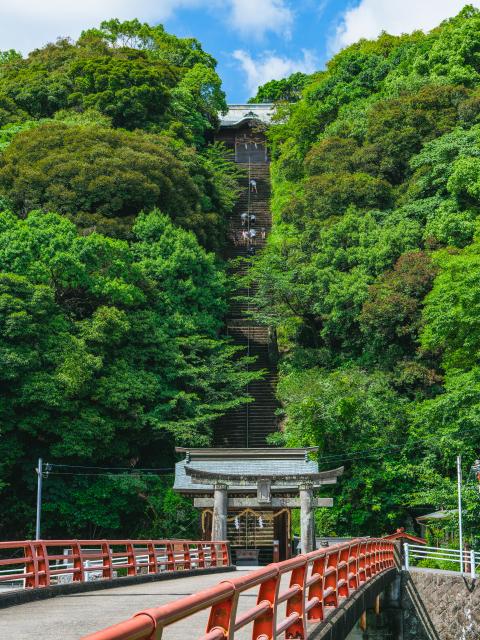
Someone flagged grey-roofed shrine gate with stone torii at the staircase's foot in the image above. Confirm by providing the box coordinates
[174,448,343,563]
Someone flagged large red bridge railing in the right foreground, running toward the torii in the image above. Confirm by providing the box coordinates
[83,539,395,640]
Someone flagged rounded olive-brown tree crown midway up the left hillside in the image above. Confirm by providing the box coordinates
[0,122,236,247]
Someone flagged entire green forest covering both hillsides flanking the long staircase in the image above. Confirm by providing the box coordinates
[0,7,480,539]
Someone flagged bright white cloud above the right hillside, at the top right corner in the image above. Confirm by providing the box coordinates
[331,0,480,51]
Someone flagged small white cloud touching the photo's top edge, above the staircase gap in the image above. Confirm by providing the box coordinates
[230,0,293,39]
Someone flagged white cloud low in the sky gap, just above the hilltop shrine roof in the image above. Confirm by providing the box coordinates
[233,49,317,95]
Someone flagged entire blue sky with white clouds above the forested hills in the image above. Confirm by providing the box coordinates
[0,0,480,102]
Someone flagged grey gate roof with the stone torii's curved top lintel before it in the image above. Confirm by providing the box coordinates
[173,448,342,493]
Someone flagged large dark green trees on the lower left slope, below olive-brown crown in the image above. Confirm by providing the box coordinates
[0,211,256,537]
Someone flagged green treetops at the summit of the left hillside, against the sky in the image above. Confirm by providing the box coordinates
[0,19,226,139]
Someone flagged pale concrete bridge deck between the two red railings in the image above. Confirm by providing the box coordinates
[0,568,396,640]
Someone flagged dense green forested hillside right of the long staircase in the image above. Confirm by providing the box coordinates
[251,7,480,536]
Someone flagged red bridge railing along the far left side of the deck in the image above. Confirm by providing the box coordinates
[0,540,230,589]
